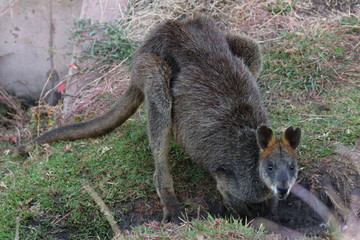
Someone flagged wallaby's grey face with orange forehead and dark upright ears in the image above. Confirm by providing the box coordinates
[256,125,301,200]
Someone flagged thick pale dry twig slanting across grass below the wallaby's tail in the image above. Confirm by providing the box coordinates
[82,182,122,240]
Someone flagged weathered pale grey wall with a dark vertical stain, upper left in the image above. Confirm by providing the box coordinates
[0,0,82,103]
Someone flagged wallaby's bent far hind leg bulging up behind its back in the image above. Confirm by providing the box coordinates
[226,34,261,76]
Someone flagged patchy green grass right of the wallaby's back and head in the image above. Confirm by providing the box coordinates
[259,25,360,163]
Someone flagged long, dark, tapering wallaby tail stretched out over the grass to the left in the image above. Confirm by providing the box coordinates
[18,85,144,152]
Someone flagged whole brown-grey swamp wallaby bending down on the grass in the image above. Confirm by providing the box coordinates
[21,16,301,221]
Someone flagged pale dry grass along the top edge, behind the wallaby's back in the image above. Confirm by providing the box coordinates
[124,0,360,41]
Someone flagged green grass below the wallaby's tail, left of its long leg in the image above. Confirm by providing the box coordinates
[0,117,155,239]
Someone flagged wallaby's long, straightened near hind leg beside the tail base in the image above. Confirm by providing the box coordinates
[135,54,181,222]
